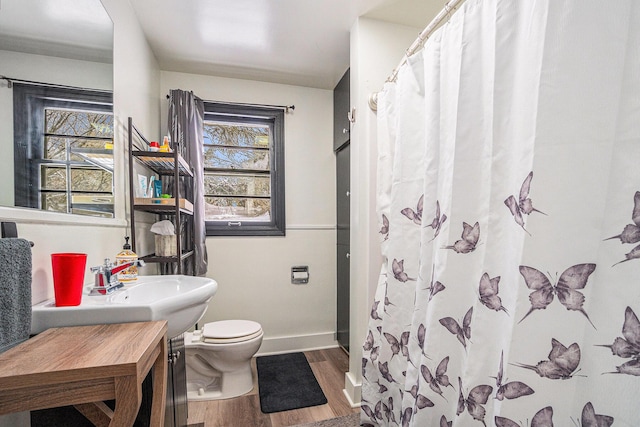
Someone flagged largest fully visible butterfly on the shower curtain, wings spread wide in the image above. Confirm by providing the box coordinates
[518,264,596,329]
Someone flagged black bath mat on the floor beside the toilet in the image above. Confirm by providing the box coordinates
[256,353,327,414]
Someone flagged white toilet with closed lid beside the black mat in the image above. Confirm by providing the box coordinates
[184,320,263,400]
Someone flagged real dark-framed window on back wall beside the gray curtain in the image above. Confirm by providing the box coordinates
[204,102,285,236]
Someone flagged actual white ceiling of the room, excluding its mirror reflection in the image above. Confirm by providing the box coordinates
[130,0,444,89]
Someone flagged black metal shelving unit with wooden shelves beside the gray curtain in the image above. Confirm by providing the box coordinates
[128,117,194,274]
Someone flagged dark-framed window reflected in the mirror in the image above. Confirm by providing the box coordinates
[13,84,113,218]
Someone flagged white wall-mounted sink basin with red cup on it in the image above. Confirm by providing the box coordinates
[31,275,218,338]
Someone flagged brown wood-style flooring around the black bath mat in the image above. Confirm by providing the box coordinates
[188,348,359,427]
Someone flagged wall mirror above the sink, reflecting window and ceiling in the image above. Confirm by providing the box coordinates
[0,0,113,216]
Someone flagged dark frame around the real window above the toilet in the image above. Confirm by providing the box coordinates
[203,101,286,236]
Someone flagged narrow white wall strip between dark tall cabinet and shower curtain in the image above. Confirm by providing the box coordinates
[345,18,421,403]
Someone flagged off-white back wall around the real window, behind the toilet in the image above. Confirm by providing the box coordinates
[161,71,336,354]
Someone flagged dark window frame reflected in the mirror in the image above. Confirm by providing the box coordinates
[13,83,115,217]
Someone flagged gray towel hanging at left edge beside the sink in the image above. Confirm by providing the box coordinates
[0,238,31,353]
